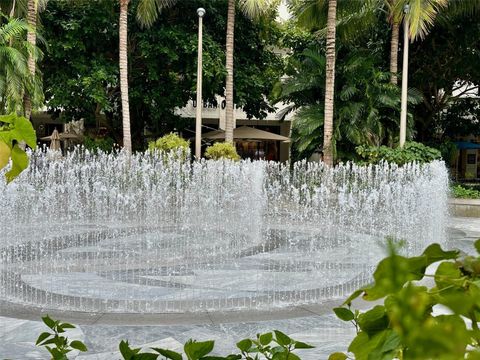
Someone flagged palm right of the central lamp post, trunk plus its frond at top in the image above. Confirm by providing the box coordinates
[225,0,279,142]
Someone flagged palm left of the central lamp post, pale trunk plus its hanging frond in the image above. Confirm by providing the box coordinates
[119,0,176,153]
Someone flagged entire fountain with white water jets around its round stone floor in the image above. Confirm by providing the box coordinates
[0,149,448,313]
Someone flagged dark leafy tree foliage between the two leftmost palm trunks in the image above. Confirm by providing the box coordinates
[42,1,119,127]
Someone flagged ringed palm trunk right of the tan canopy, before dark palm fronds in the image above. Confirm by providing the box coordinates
[323,0,337,166]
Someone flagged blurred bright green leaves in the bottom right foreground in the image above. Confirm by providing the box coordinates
[329,240,480,360]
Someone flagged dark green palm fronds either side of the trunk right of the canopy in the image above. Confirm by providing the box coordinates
[274,45,420,162]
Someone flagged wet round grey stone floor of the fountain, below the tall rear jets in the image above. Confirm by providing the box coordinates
[1,227,380,313]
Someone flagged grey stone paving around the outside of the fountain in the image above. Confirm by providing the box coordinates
[0,218,480,360]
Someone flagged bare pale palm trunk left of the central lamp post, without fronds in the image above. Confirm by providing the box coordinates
[119,0,132,153]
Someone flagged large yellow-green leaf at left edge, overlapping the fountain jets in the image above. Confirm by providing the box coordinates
[0,114,37,183]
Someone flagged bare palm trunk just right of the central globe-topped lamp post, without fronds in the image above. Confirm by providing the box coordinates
[224,0,235,143]
